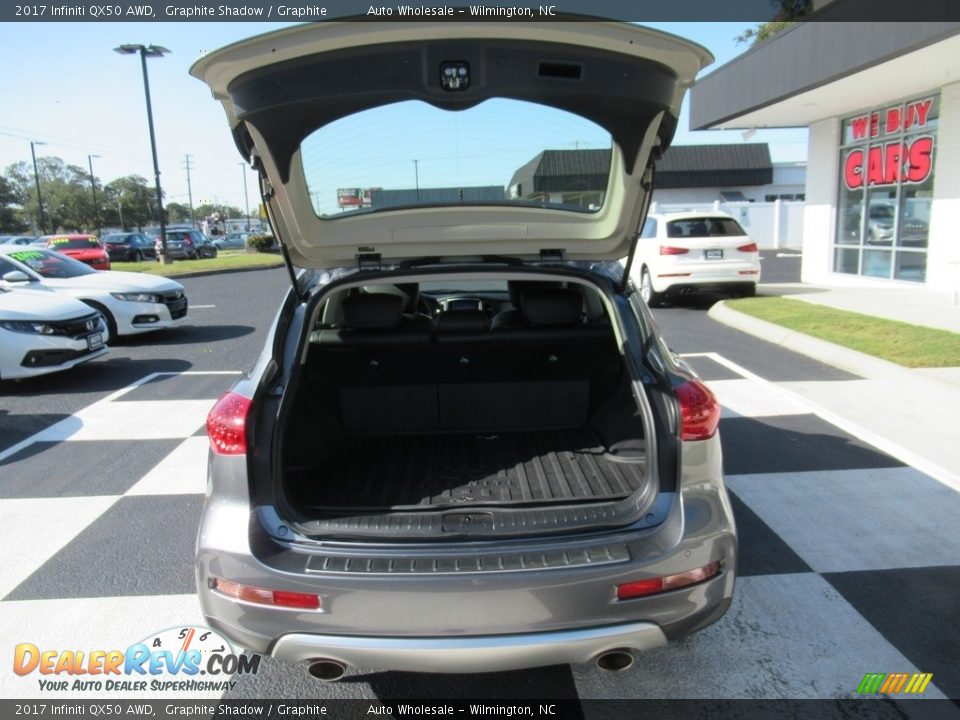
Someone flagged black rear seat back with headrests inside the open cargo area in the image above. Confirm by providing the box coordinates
[308,284,622,433]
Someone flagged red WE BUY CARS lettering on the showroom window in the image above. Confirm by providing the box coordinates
[843,98,933,190]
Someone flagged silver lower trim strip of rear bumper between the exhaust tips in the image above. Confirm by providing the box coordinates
[270,622,667,673]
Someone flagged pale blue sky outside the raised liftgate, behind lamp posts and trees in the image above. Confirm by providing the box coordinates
[0,22,806,212]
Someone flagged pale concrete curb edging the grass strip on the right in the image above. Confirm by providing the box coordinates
[707,301,949,388]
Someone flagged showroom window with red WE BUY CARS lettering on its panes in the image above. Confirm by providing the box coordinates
[833,96,940,282]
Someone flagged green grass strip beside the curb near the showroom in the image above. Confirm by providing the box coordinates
[727,297,960,368]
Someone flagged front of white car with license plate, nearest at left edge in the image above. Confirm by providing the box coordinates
[0,284,108,380]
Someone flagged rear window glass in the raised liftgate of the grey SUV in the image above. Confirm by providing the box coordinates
[300,99,612,218]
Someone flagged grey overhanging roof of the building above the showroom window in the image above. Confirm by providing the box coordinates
[690,20,960,130]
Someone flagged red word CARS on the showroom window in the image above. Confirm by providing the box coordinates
[843,135,933,190]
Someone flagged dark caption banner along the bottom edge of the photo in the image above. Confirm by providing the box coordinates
[7,698,960,720]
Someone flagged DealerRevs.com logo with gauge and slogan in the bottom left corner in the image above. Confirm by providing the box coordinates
[13,627,260,692]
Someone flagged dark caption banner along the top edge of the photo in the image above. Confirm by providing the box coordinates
[0,0,960,22]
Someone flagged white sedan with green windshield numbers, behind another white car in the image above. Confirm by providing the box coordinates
[0,246,187,337]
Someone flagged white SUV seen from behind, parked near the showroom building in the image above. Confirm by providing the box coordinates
[630,212,760,306]
